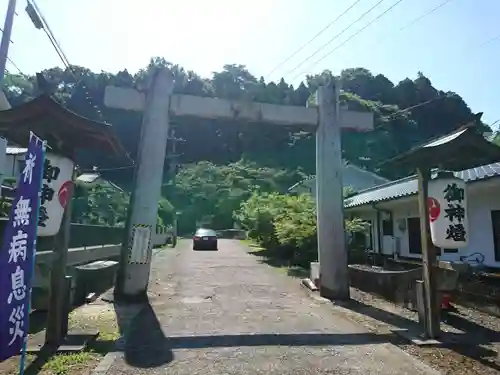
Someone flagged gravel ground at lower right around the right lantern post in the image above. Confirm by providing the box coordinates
[332,288,500,375]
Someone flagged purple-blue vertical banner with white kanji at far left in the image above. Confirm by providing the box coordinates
[0,133,45,362]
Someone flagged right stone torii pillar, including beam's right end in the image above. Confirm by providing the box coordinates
[316,82,373,300]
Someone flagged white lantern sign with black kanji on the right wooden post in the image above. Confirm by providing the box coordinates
[427,172,469,249]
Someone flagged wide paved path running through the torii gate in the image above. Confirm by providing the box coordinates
[100,240,438,375]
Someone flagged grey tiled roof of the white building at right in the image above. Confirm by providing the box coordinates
[344,163,500,208]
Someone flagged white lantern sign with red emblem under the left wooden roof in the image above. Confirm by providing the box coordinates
[38,152,74,237]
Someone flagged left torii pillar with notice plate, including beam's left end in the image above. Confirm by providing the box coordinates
[104,69,174,302]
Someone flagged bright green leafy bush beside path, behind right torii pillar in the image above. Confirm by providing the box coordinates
[234,193,365,266]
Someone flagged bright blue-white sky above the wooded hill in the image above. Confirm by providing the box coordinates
[0,0,500,127]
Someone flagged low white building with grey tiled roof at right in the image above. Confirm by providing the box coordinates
[345,163,500,267]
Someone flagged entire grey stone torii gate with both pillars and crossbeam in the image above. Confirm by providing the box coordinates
[104,68,373,301]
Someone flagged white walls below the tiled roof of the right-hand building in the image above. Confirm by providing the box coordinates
[347,179,500,268]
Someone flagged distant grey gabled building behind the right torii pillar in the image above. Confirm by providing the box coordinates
[288,161,389,196]
